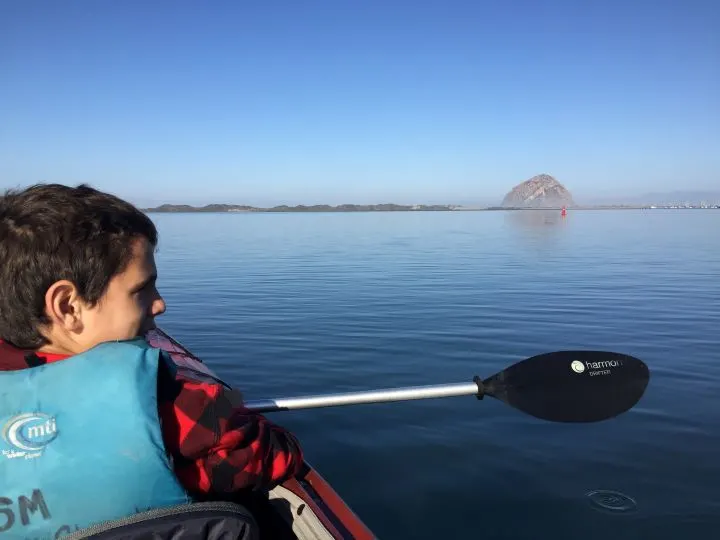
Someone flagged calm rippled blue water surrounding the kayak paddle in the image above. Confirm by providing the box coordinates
[153,210,720,540]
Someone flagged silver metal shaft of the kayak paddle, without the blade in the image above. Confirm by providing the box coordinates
[245,382,479,413]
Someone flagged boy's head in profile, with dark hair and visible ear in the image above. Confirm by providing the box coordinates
[0,184,165,354]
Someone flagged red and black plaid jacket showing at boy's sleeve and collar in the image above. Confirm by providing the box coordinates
[0,340,303,497]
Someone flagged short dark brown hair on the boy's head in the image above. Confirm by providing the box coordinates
[0,184,157,349]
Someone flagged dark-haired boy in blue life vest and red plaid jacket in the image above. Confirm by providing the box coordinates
[0,184,303,536]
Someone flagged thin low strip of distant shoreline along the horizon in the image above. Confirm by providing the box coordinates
[142,204,720,214]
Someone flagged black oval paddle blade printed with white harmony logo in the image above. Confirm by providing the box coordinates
[483,351,650,422]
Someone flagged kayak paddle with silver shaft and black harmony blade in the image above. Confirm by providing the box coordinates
[245,351,650,422]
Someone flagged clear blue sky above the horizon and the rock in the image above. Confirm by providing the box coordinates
[0,0,720,205]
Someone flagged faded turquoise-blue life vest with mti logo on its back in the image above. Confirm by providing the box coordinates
[0,339,191,539]
